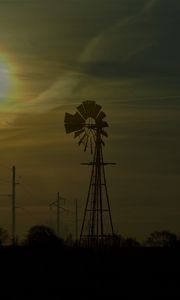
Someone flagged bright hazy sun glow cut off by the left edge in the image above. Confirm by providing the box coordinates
[0,53,19,110]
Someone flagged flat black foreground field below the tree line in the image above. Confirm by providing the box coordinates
[0,247,180,299]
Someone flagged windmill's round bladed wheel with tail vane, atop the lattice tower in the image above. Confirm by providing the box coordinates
[64,100,108,153]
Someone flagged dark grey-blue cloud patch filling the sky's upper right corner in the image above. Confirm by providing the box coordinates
[81,1,180,83]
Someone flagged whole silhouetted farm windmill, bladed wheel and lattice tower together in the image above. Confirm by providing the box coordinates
[64,101,114,245]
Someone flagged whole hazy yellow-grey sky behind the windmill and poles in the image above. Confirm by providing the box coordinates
[0,0,180,239]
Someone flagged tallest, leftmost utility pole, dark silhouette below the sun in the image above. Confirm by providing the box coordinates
[12,166,16,246]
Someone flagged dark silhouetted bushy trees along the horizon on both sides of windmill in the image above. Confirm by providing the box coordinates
[0,225,180,248]
